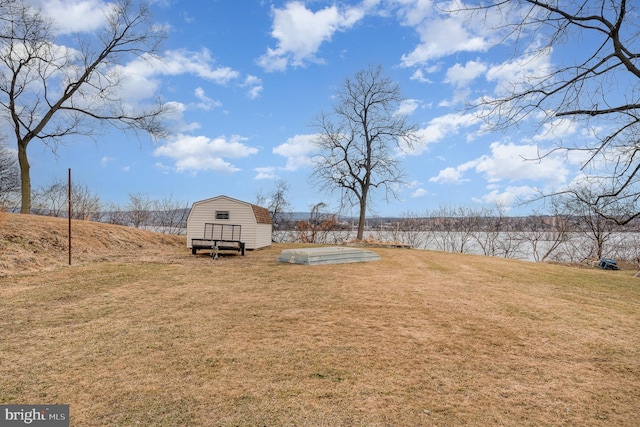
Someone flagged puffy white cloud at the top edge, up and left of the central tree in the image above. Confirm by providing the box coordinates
[258,1,364,71]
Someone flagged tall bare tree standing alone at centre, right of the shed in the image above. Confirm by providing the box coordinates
[311,66,416,239]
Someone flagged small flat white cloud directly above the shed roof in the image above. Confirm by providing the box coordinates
[154,135,258,173]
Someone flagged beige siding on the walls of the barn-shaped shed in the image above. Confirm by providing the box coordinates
[187,196,271,249]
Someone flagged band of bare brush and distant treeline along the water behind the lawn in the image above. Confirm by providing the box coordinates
[6,177,640,262]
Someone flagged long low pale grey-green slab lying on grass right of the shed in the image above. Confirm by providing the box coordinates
[277,246,380,265]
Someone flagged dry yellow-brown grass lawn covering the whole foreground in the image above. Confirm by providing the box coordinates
[0,216,640,426]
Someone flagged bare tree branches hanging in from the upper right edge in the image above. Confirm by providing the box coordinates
[457,0,640,223]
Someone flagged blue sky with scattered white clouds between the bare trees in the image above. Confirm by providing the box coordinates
[15,0,612,216]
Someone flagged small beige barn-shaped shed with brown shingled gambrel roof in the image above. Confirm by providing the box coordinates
[187,196,272,250]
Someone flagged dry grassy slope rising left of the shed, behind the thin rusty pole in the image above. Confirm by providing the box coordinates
[0,212,186,276]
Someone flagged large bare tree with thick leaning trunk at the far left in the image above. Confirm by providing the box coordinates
[0,0,165,213]
